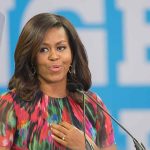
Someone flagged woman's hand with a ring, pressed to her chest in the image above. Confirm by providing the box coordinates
[51,122,85,150]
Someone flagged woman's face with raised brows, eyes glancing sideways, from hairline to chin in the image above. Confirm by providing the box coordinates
[37,27,72,85]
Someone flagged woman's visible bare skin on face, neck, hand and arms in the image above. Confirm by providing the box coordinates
[0,28,116,150]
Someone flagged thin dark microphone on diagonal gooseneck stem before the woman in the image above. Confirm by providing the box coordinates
[68,83,146,150]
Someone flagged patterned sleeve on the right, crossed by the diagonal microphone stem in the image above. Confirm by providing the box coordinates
[96,95,115,148]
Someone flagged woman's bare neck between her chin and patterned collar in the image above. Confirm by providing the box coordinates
[40,83,67,98]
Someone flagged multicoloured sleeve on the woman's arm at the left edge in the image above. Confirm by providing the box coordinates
[0,93,16,148]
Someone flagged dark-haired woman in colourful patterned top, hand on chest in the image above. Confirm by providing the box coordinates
[0,13,116,150]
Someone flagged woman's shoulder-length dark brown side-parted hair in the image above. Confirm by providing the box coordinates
[8,13,91,100]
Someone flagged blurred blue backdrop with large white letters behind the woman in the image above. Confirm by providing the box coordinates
[0,0,150,150]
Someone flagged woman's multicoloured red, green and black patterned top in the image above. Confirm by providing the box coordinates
[0,91,114,150]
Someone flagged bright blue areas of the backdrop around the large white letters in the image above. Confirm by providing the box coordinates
[0,0,150,150]
